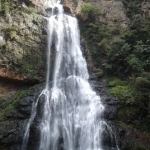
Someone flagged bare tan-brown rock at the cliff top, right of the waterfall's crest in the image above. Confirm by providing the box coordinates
[64,0,129,26]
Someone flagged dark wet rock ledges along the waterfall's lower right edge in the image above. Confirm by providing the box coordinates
[90,78,119,150]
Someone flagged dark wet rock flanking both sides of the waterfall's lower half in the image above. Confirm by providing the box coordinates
[0,79,120,150]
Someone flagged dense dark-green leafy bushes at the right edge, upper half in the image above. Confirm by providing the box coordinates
[107,15,150,76]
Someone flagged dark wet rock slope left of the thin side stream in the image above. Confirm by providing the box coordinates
[0,85,43,150]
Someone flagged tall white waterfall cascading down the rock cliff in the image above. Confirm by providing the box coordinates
[22,0,104,150]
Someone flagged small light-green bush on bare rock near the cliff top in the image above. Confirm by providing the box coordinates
[80,3,100,20]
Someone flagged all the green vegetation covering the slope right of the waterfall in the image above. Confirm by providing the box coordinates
[79,0,150,134]
